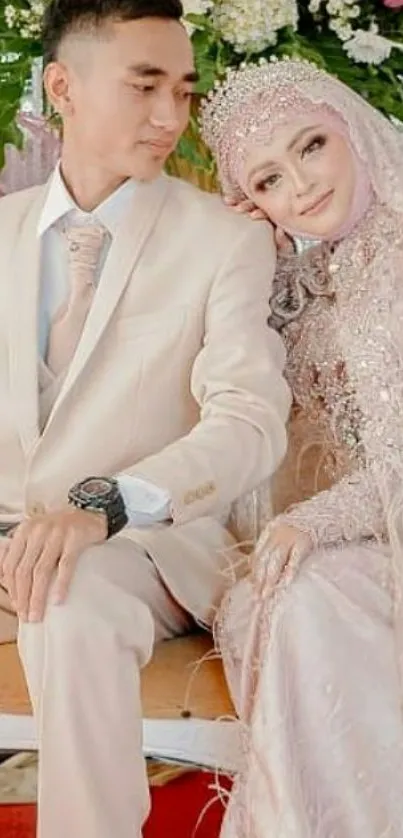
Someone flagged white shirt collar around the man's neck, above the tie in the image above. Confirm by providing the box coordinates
[37,163,136,237]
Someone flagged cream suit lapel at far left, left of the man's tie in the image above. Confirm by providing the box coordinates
[9,185,48,456]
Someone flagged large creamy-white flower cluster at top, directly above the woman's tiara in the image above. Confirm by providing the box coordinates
[214,0,298,53]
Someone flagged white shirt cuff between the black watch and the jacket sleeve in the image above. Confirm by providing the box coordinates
[117,474,172,528]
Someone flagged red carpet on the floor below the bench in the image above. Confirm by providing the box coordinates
[0,773,229,838]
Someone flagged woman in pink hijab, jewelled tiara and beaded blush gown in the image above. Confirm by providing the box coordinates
[203,61,403,838]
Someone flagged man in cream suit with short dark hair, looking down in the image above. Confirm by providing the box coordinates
[0,0,289,838]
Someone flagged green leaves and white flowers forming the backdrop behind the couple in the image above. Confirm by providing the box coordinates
[0,0,403,174]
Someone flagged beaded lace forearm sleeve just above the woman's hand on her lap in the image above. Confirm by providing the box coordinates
[276,468,385,546]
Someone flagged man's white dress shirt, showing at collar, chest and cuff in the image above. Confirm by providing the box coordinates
[38,166,170,527]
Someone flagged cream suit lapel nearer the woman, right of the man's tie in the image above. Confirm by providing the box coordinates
[48,177,169,424]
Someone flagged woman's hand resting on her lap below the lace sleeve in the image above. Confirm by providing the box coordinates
[252,523,315,596]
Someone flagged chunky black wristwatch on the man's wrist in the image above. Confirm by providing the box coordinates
[68,477,129,538]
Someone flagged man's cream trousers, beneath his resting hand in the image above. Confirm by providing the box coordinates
[3,537,191,838]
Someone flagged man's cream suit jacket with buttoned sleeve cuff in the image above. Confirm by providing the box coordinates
[0,176,289,620]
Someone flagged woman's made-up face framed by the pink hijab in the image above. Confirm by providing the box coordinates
[242,115,356,239]
